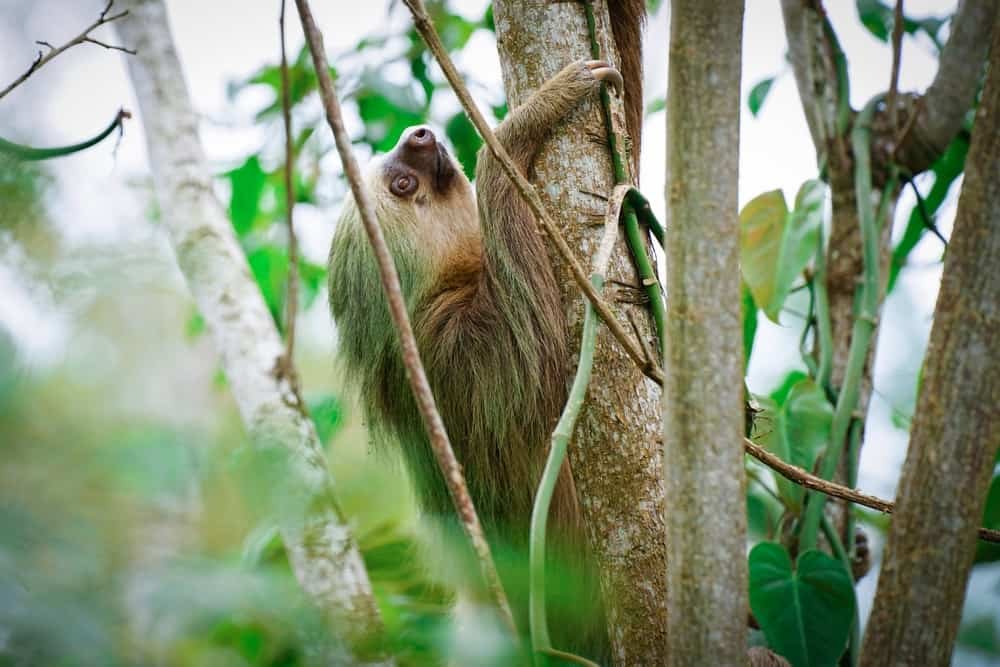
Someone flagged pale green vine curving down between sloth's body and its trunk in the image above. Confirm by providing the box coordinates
[528,273,604,664]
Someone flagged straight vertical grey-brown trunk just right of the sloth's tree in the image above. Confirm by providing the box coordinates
[663,0,749,665]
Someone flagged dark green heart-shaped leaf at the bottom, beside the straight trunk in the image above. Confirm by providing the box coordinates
[749,542,855,667]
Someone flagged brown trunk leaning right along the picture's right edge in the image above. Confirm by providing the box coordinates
[862,17,1000,665]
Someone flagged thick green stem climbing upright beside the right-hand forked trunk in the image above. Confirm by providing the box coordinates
[799,96,881,550]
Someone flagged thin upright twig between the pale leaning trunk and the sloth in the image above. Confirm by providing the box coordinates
[275,0,306,413]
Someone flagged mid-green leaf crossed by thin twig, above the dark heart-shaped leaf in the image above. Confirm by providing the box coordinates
[757,377,833,510]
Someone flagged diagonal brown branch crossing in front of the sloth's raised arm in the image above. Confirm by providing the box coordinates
[403,0,663,386]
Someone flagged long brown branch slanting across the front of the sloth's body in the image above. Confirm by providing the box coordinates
[295,0,517,636]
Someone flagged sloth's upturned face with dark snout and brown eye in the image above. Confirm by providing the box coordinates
[382,125,465,204]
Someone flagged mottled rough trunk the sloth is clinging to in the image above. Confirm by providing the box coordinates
[494,0,666,664]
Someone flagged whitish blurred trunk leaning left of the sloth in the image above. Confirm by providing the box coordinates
[117,0,381,656]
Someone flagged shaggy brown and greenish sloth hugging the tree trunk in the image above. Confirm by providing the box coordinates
[329,60,641,646]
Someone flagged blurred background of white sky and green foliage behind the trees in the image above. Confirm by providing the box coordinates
[0,0,1000,665]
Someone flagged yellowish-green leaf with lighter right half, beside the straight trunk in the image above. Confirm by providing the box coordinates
[740,181,825,323]
